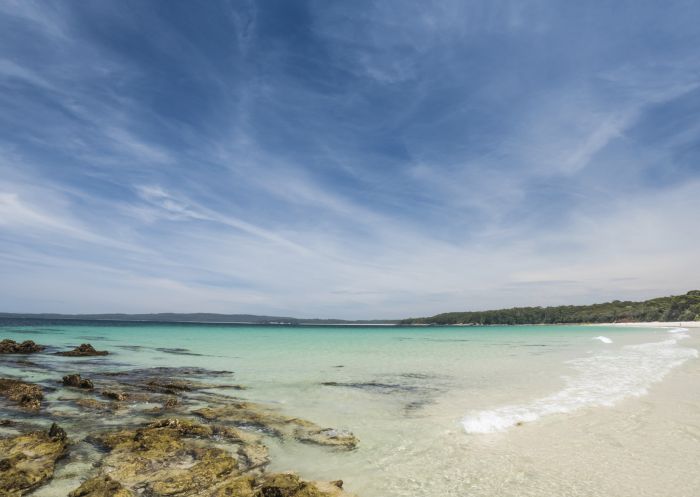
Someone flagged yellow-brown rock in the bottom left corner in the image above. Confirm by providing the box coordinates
[0,425,67,497]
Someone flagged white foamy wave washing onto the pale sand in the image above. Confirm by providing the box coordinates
[462,328,698,433]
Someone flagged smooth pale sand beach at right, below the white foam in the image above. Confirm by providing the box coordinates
[468,322,700,497]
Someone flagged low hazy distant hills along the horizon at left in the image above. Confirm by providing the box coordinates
[0,312,397,325]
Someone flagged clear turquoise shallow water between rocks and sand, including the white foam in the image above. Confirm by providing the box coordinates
[0,322,698,497]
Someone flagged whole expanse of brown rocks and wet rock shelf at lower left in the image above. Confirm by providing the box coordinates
[0,352,357,497]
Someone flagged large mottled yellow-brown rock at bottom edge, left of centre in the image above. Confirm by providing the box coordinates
[69,418,348,497]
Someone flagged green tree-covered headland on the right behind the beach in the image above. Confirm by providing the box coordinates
[399,290,700,325]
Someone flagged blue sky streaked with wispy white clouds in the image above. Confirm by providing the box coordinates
[0,0,700,318]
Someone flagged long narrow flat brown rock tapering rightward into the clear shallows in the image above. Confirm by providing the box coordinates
[192,401,358,450]
